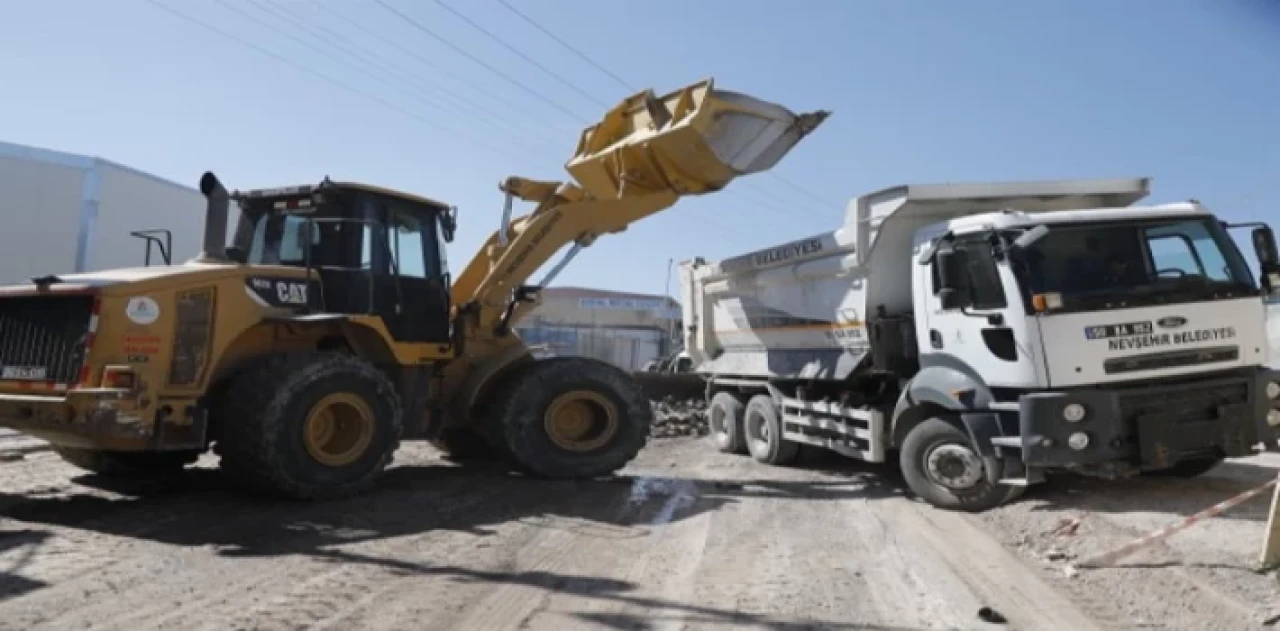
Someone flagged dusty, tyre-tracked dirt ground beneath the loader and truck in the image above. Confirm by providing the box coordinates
[0,436,1276,631]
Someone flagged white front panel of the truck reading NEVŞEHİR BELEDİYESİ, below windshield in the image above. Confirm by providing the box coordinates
[1039,297,1267,388]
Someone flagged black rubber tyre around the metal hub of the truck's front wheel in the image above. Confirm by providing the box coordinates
[899,419,1024,512]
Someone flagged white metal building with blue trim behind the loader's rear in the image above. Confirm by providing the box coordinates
[0,142,205,283]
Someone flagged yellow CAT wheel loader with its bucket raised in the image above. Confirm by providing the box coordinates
[0,79,828,499]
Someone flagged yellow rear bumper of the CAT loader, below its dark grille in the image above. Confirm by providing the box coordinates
[0,389,167,451]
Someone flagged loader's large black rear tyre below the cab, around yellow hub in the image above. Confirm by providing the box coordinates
[218,352,403,499]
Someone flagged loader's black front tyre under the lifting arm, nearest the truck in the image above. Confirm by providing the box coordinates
[492,357,653,479]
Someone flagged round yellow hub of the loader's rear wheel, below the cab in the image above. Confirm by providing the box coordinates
[302,393,375,467]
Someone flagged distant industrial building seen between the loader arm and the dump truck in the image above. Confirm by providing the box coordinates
[516,287,680,370]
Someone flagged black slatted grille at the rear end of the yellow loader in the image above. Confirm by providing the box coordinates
[0,296,95,384]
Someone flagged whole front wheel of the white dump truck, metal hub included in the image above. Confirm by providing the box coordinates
[899,419,1023,512]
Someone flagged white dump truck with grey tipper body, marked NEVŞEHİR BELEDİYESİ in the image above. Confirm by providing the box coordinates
[681,178,1280,511]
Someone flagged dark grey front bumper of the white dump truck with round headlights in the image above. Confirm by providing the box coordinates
[1002,370,1280,470]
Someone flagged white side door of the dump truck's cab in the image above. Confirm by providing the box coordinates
[916,233,1041,388]
